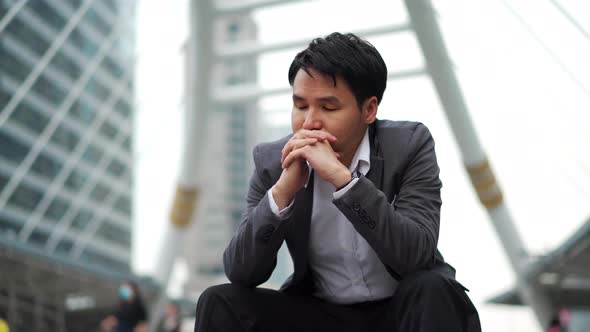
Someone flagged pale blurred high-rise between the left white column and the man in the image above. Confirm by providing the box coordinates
[184,8,258,293]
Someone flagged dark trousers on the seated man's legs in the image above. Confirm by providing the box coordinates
[195,271,481,332]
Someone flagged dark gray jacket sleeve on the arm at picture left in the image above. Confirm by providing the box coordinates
[223,146,290,287]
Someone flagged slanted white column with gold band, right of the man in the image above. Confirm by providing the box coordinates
[405,0,553,326]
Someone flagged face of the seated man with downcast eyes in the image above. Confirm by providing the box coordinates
[291,69,377,162]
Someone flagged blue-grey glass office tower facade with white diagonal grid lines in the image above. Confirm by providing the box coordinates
[0,0,133,271]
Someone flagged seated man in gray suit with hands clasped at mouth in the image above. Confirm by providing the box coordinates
[195,33,481,332]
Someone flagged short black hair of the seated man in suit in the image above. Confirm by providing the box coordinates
[289,32,387,109]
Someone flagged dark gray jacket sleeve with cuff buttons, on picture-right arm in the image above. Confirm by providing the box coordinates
[334,124,442,280]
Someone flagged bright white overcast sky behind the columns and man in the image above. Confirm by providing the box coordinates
[133,0,590,332]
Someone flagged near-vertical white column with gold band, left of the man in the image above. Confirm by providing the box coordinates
[150,0,214,331]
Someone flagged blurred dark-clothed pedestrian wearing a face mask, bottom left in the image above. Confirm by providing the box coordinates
[100,281,147,332]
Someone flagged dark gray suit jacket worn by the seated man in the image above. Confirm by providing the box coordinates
[223,120,454,295]
